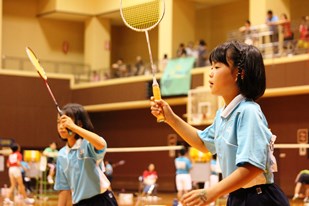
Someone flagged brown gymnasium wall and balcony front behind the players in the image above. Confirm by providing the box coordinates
[0,55,309,195]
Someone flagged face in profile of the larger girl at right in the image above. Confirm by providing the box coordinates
[209,62,239,103]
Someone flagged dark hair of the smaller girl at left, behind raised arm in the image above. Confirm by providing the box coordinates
[62,103,94,139]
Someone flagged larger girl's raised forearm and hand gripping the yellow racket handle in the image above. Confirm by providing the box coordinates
[150,97,208,153]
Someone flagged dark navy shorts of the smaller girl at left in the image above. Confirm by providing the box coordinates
[74,190,118,206]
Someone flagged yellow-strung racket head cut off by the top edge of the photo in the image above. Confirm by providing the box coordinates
[120,0,165,32]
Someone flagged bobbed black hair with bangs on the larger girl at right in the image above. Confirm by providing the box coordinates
[209,41,266,100]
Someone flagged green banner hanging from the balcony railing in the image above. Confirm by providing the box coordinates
[160,57,195,96]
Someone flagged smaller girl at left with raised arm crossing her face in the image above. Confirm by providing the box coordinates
[55,103,118,206]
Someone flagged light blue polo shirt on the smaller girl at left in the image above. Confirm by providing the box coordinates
[54,139,110,204]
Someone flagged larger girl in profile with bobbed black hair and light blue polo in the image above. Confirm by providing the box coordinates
[150,41,289,206]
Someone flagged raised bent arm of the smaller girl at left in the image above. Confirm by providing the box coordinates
[60,115,106,150]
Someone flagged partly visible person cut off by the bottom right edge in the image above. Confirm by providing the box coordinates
[293,170,309,203]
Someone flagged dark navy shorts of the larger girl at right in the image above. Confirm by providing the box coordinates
[226,184,290,206]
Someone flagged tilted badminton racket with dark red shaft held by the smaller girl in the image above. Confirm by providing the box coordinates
[26,47,71,134]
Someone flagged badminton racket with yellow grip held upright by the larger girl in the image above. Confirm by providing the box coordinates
[120,0,165,122]
